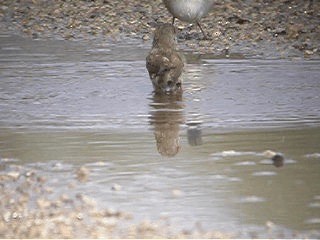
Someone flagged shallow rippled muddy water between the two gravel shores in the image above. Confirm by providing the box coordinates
[0,33,320,237]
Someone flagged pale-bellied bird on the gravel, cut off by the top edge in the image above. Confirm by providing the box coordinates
[163,0,213,39]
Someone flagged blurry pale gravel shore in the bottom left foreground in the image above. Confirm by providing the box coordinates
[0,159,232,238]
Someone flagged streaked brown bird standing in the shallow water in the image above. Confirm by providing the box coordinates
[146,24,184,94]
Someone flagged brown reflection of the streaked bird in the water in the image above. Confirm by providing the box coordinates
[150,94,184,157]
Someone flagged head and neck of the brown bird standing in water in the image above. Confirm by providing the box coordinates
[152,23,177,49]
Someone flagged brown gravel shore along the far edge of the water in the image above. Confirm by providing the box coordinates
[0,0,320,59]
